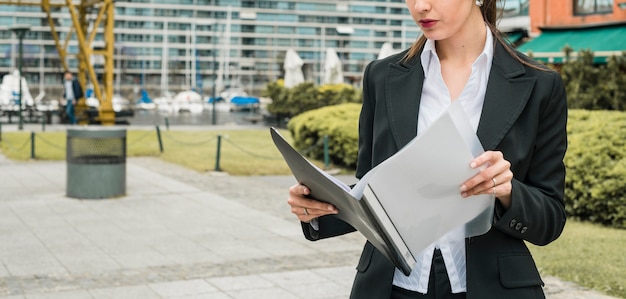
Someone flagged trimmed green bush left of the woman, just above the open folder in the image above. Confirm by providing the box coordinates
[287,103,361,168]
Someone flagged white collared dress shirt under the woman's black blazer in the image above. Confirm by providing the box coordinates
[393,26,494,294]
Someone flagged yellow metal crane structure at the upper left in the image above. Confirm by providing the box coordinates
[0,0,115,125]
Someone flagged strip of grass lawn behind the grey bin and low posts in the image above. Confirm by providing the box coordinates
[0,129,298,175]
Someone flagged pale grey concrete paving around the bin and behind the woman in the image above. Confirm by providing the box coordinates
[0,155,610,299]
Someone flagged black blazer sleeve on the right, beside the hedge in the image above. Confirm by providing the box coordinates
[494,72,567,245]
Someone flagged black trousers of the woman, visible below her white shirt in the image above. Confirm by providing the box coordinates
[390,249,465,299]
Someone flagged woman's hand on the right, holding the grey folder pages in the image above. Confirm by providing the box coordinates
[461,151,513,209]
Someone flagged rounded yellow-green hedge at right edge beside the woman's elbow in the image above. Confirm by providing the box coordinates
[564,110,626,228]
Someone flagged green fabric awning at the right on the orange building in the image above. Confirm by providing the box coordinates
[518,24,626,63]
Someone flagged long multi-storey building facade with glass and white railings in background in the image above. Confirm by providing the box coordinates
[0,0,528,96]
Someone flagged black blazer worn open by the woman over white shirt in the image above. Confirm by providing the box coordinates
[303,43,567,299]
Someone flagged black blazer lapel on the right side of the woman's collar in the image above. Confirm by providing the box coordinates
[477,43,536,150]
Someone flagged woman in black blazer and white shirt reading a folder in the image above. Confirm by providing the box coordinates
[288,0,567,299]
